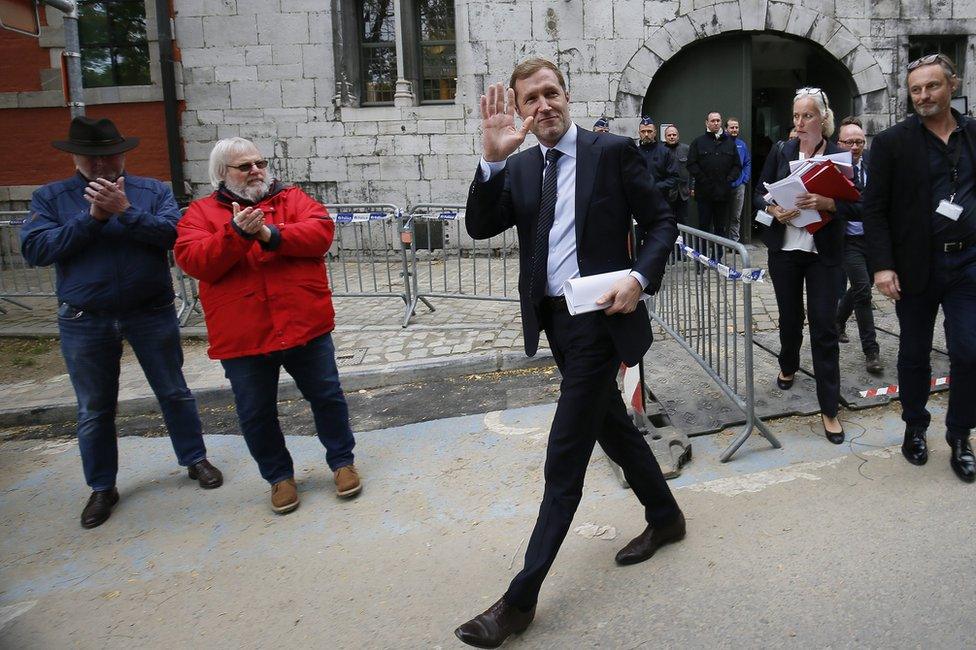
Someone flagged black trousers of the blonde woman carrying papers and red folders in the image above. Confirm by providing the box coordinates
[769,251,842,417]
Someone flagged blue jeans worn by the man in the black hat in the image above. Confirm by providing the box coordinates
[58,302,207,490]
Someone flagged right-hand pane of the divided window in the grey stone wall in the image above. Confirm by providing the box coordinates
[416,0,457,103]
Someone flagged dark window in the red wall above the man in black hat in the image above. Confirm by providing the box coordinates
[78,0,152,88]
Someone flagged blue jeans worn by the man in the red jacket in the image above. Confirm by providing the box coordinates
[220,334,356,484]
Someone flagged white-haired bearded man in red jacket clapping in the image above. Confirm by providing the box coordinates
[174,138,362,514]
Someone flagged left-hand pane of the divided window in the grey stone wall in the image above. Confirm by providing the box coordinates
[359,0,397,104]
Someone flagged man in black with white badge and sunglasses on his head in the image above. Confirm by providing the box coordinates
[863,54,976,483]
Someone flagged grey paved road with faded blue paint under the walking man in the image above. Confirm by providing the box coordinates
[0,388,976,648]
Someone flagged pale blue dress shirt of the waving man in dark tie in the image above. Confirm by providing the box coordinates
[480,123,647,296]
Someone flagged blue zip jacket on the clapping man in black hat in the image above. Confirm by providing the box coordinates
[20,174,180,314]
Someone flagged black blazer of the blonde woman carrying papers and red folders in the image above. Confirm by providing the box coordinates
[753,138,856,266]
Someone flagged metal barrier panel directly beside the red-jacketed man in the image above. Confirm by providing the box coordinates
[325,203,413,326]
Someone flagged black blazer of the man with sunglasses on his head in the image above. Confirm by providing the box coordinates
[862,111,976,294]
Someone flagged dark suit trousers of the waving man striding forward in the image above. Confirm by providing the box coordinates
[505,306,680,609]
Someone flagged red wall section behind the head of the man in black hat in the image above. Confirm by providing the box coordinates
[0,101,170,185]
